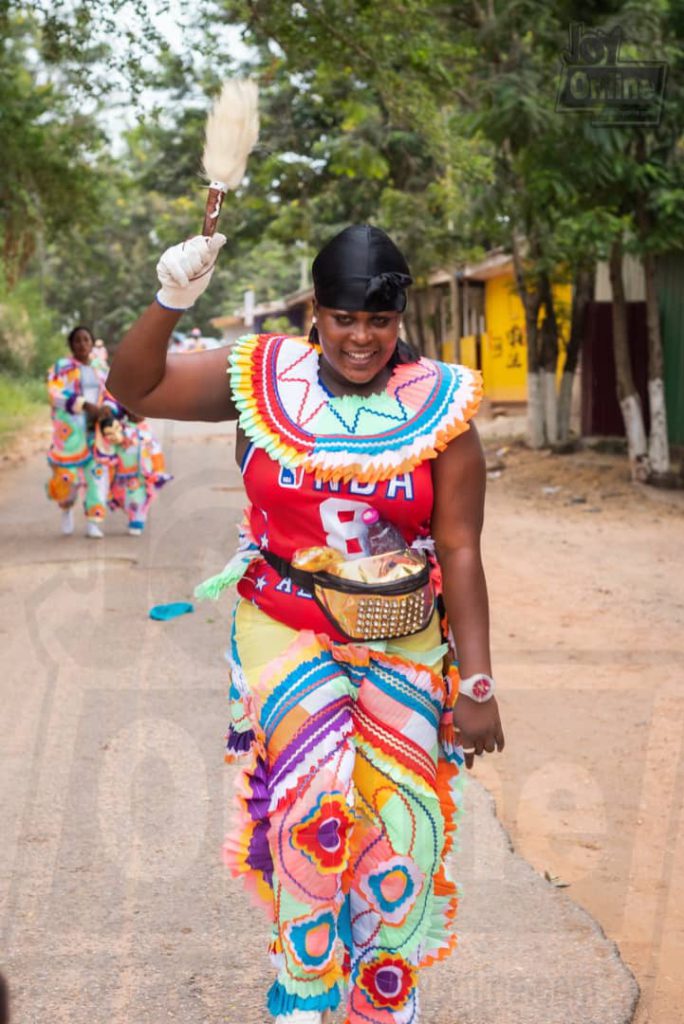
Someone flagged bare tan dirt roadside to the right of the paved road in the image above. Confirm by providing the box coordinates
[475,440,684,1024]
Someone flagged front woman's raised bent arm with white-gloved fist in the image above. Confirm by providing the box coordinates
[106,234,238,422]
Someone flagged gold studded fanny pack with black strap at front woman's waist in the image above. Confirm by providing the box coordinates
[261,550,434,640]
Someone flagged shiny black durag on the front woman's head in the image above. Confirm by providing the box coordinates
[311,224,413,313]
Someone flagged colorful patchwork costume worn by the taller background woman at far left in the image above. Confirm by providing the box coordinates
[46,356,109,522]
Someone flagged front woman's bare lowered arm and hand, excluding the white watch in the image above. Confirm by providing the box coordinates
[432,424,504,767]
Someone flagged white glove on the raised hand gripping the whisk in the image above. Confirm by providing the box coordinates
[157,233,226,311]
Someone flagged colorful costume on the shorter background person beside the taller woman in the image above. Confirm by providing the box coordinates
[95,401,173,529]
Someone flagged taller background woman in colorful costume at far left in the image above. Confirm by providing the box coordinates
[46,327,109,540]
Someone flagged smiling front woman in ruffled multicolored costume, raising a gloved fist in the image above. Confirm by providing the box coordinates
[110,225,504,1024]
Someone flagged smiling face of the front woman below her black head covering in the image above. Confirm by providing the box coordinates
[315,305,400,394]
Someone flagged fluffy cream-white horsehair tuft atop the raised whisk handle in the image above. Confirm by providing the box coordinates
[202,78,259,189]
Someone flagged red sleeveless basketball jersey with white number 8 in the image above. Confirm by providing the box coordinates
[238,445,433,640]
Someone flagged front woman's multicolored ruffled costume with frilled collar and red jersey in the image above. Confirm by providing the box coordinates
[208,335,481,1024]
